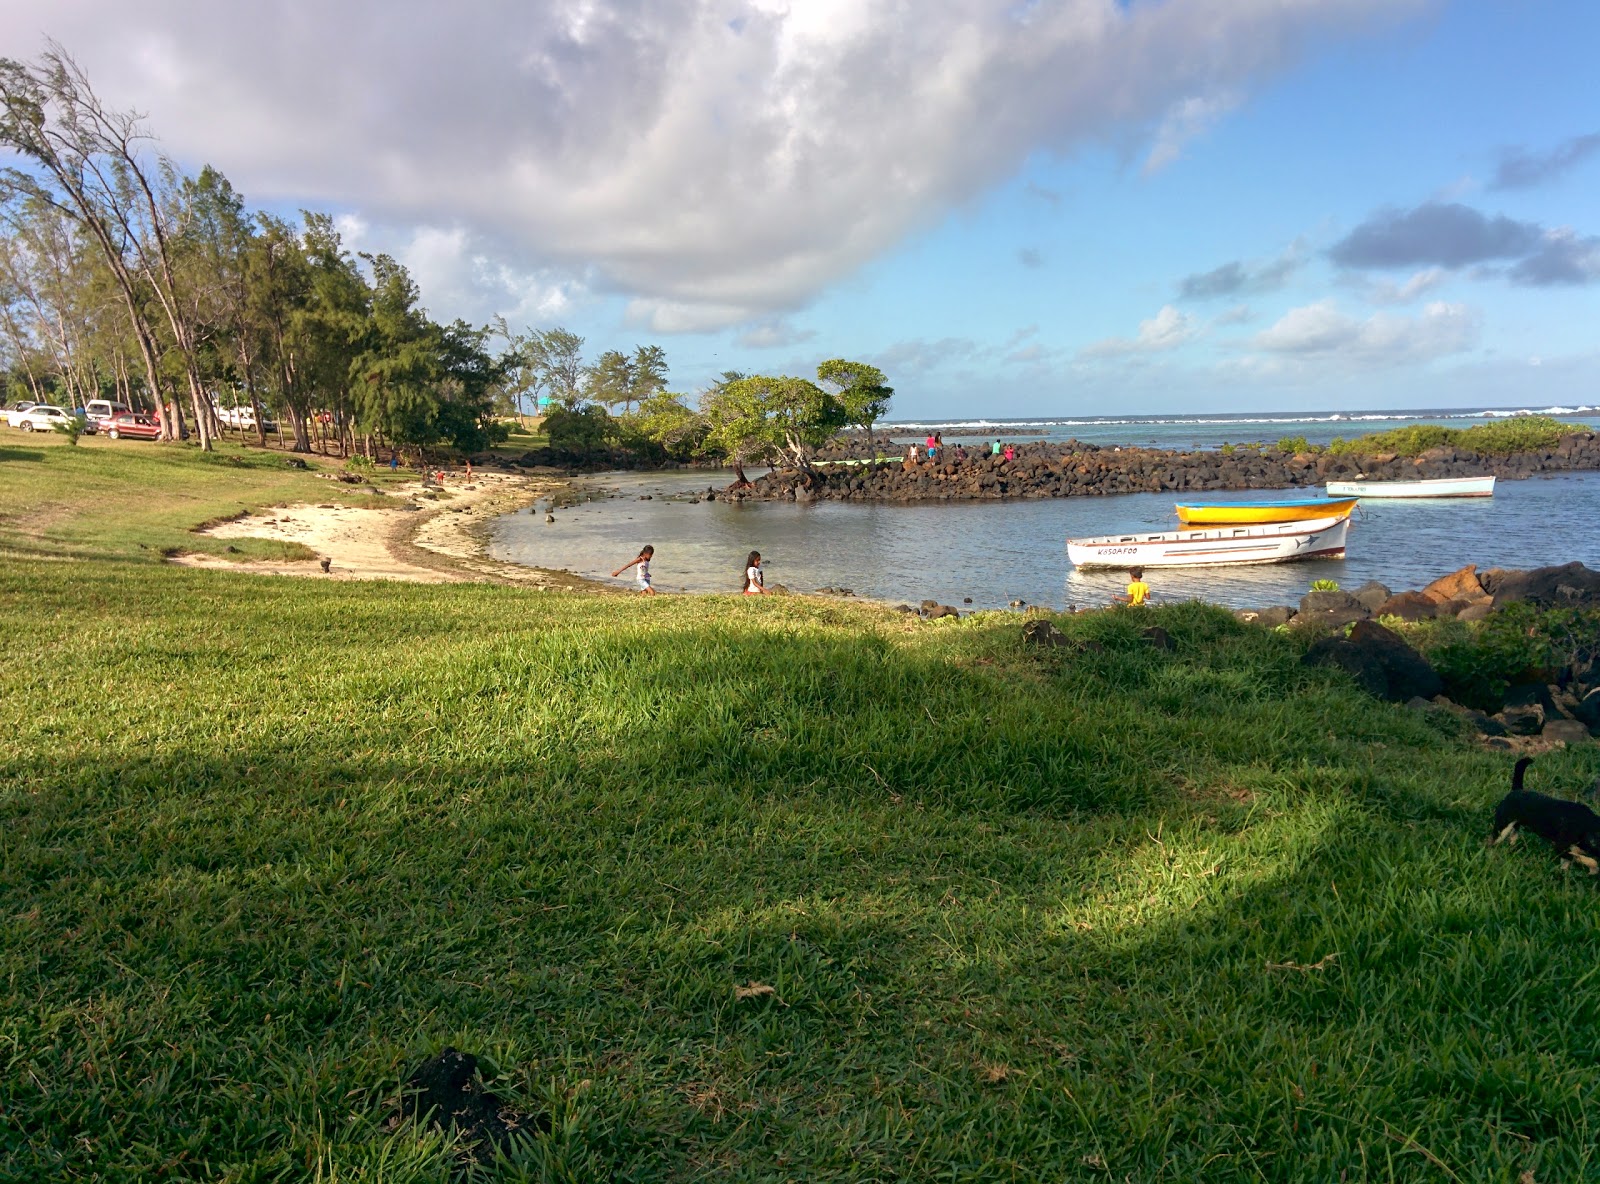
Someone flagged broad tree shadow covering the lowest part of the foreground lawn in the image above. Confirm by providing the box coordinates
[5,745,1600,1181]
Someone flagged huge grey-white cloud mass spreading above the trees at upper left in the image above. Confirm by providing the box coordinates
[12,0,1427,331]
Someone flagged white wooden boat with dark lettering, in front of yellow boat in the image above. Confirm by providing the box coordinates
[1067,514,1350,568]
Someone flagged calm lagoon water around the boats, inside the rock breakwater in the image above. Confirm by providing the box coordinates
[490,470,1600,608]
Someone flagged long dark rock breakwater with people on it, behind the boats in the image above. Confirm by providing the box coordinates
[739,432,1600,502]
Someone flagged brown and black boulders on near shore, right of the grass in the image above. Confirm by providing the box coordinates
[1237,563,1600,747]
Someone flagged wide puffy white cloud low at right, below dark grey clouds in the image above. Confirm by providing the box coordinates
[1251,301,1478,365]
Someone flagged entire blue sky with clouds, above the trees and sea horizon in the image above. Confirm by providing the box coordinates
[12,0,1600,419]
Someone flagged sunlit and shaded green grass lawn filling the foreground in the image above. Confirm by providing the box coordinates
[0,438,1600,1184]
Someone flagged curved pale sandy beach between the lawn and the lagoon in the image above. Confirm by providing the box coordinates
[171,472,600,590]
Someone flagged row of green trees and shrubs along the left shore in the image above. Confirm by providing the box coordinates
[0,45,893,476]
